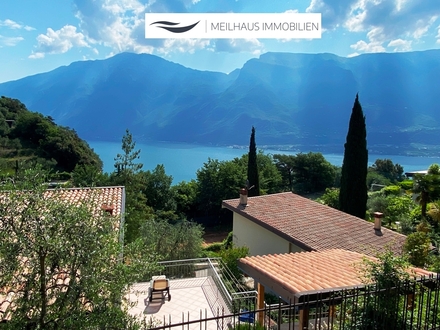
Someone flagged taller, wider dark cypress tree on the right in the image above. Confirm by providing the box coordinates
[339,94,368,219]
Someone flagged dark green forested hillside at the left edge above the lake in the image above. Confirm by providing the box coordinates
[0,96,102,173]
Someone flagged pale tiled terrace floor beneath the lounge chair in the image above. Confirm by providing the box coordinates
[129,277,223,330]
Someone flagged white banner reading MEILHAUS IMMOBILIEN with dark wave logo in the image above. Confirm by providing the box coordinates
[145,13,321,39]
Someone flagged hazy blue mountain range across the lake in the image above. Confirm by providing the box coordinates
[0,50,440,154]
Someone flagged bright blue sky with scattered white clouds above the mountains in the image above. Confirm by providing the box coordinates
[0,0,440,83]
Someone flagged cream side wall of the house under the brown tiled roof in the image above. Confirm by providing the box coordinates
[233,212,302,256]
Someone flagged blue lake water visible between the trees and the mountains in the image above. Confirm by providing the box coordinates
[89,142,440,184]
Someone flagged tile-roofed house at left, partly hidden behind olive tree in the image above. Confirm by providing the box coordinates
[0,186,125,322]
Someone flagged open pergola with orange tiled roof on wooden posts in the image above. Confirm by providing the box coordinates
[238,249,433,329]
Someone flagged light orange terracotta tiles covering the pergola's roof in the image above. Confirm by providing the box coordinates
[238,249,434,295]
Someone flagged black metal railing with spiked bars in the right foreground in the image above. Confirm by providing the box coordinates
[147,275,440,330]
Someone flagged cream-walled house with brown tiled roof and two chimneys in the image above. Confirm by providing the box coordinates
[222,192,406,256]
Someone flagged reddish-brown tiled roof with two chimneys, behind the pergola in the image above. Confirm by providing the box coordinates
[222,192,406,256]
